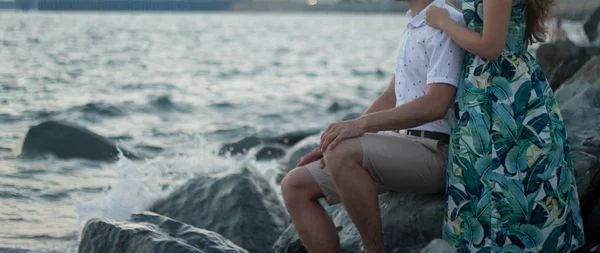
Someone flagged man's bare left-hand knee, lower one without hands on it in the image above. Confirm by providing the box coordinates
[281,167,322,206]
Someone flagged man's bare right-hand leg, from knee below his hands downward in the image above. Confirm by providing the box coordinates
[325,139,385,253]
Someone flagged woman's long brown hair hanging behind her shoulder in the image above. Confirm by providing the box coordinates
[524,0,555,43]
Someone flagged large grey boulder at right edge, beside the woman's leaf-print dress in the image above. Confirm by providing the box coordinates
[556,63,600,249]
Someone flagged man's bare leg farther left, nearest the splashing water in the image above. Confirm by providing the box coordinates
[281,167,340,253]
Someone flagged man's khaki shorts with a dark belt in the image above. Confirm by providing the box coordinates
[305,133,448,205]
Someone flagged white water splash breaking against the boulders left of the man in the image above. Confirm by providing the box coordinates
[74,135,238,234]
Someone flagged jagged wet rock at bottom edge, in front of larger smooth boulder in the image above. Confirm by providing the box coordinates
[78,212,248,253]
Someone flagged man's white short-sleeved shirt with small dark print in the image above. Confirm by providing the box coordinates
[395,0,465,133]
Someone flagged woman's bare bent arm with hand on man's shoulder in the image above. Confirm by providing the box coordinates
[426,0,513,60]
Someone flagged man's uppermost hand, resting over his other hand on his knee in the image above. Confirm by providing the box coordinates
[321,118,365,153]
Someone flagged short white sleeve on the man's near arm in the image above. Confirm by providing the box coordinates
[426,29,465,87]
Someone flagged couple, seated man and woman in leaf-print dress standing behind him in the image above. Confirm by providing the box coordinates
[281,0,584,253]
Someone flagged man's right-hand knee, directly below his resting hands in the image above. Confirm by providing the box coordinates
[324,138,363,176]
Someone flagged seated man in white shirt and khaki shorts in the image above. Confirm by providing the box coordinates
[281,0,464,253]
